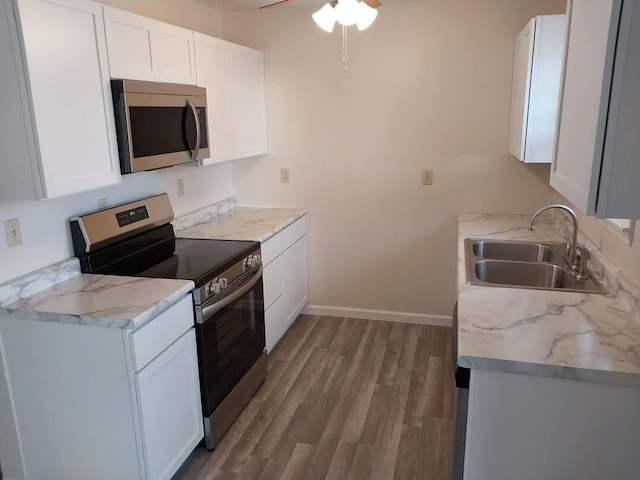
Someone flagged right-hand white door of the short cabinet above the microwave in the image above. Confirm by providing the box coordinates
[151,22,196,85]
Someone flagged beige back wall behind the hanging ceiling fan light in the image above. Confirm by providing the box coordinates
[223,0,566,315]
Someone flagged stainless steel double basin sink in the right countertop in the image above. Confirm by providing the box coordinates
[464,238,604,293]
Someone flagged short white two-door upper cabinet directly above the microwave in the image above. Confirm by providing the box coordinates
[104,5,196,85]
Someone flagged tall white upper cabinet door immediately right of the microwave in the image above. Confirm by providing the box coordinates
[194,32,231,165]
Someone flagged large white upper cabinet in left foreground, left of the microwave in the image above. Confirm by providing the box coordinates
[0,0,120,199]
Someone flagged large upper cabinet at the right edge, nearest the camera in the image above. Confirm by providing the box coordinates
[550,0,640,218]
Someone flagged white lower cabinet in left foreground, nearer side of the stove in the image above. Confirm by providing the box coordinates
[0,295,204,480]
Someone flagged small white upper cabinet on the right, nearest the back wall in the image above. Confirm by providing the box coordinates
[509,15,565,163]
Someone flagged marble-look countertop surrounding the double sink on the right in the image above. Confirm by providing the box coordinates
[457,213,640,387]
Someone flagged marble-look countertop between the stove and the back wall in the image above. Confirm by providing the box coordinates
[173,205,307,242]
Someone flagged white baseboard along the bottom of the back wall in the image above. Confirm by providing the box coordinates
[302,305,453,327]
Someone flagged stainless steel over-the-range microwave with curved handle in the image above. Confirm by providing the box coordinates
[111,79,210,174]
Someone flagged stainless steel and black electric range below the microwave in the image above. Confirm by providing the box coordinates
[70,194,267,449]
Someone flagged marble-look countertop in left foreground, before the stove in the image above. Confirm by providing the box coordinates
[0,258,194,329]
